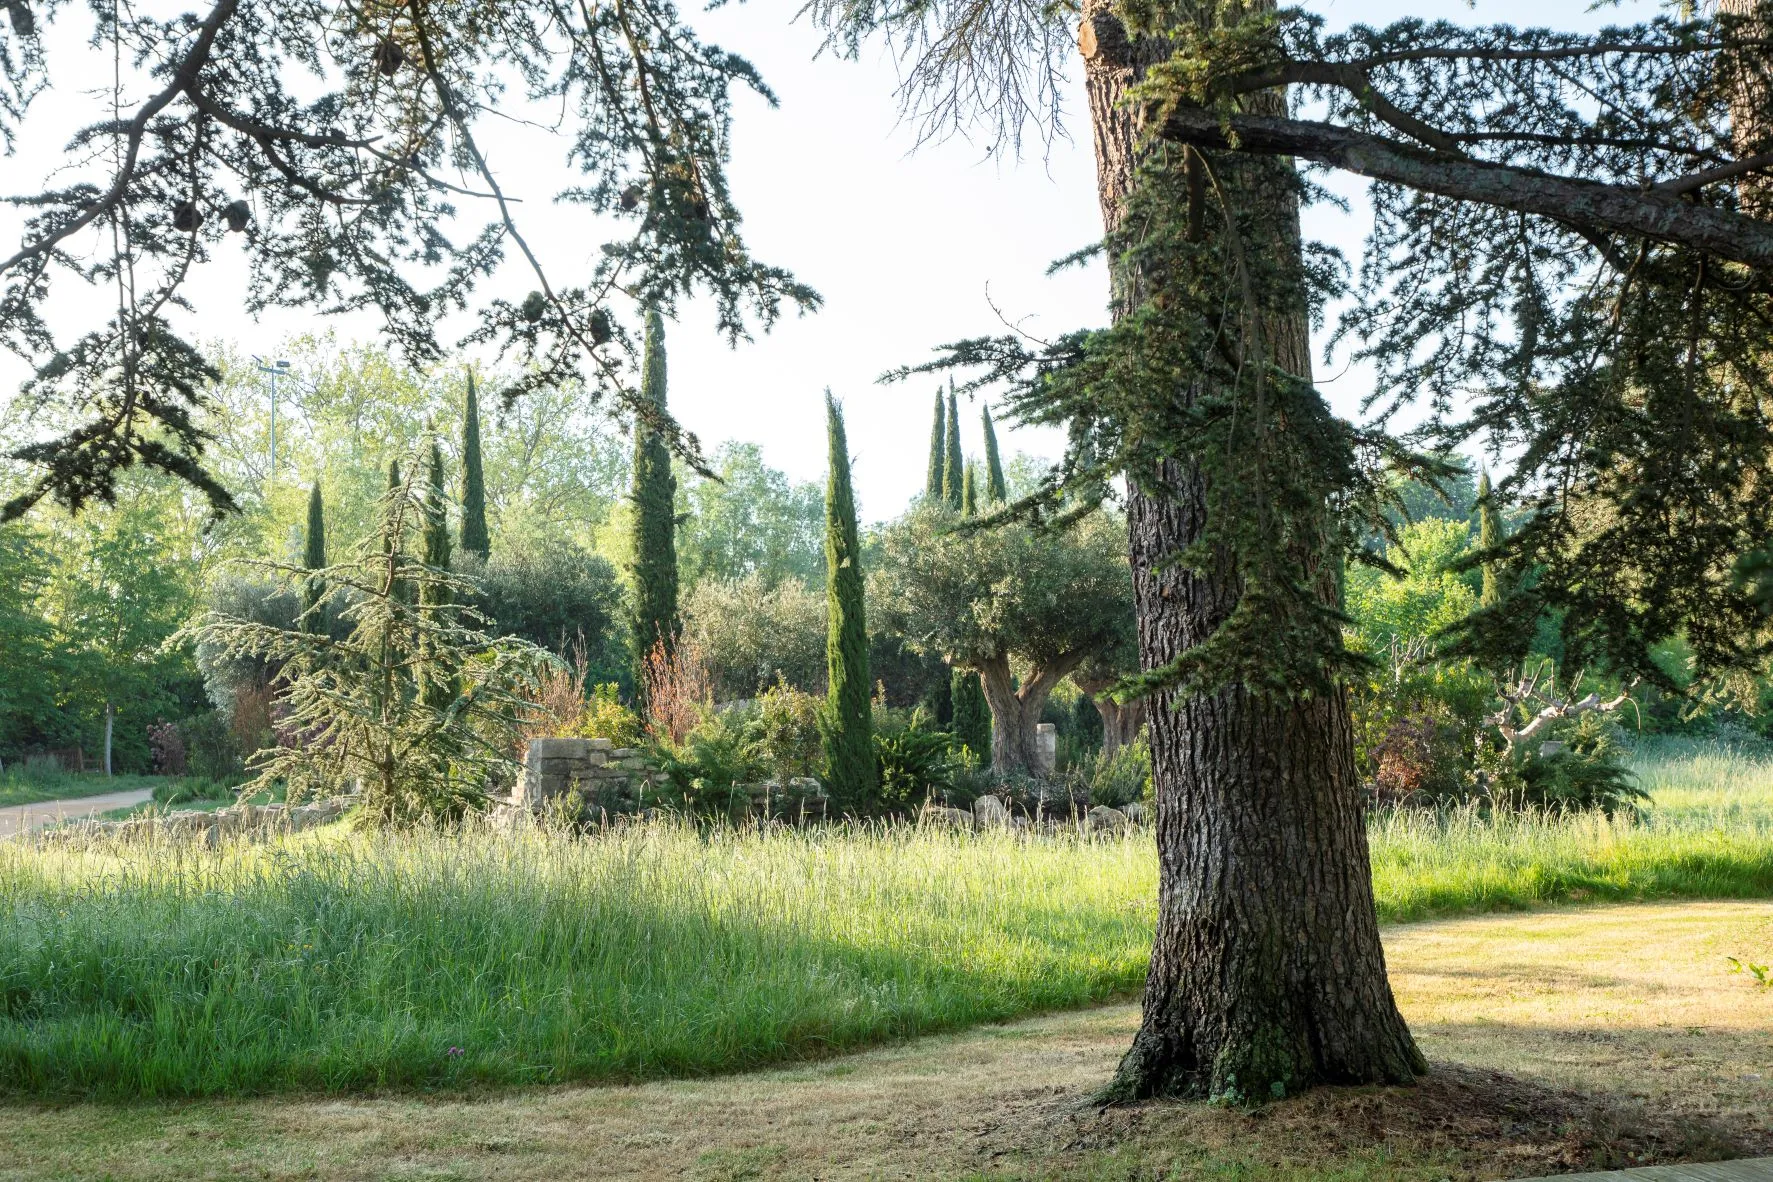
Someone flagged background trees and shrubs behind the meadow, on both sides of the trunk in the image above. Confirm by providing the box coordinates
[0,337,1773,805]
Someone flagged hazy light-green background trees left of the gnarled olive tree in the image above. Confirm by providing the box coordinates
[0,337,936,774]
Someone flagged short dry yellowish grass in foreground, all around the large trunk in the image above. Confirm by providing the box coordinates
[0,904,1773,1180]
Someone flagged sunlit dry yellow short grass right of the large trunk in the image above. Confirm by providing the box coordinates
[1386,904,1773,1138]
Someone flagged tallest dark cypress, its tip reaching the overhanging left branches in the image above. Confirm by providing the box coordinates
[629,310,677,684]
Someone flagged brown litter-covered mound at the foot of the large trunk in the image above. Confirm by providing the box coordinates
[988,1063,1773,1178]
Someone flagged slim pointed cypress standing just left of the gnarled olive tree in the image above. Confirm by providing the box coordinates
[824,390,878,812]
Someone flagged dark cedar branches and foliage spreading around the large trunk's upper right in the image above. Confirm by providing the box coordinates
[822,0,1773,686]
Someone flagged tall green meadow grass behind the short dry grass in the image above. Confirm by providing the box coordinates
[0,740,1773,1097]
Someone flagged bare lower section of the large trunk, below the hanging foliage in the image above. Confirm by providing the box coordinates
[1105,689,1427,1104]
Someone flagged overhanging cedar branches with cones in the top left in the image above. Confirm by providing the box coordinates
[0,0,817,517]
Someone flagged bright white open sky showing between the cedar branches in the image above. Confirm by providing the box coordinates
[0,0,1658,521]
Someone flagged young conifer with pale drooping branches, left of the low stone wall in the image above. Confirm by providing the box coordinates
[193,466,555,826]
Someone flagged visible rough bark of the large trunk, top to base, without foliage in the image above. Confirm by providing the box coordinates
[1080,0,1425,1100]
